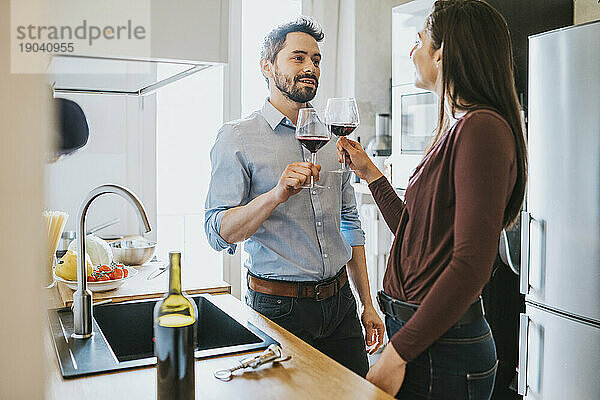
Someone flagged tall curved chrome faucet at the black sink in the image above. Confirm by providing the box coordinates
[72,184,152,339]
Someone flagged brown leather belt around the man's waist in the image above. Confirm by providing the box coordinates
[248,266,348,301]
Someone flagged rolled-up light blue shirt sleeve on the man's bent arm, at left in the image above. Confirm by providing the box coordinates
[204,124,250,254]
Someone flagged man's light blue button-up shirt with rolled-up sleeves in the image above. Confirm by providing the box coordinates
[204,100,365,281]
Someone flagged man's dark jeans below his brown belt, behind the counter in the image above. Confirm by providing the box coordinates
[246,283,369,378]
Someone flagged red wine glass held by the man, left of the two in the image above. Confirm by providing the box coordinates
[296,108,331,189]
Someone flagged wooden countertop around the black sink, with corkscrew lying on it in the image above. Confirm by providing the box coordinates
[45,289,393,400]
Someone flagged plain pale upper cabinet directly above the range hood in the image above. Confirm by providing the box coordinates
[48,0,229,63]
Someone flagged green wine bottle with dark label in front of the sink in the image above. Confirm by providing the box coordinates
[154,251,198,400]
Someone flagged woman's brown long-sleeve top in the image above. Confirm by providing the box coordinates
[369,109,516,361]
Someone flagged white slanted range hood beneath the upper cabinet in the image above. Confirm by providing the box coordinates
[48,55,217,96]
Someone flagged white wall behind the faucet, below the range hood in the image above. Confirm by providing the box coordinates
[45,94,156,239]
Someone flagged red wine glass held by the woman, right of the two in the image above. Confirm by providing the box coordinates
[325,97,360,173]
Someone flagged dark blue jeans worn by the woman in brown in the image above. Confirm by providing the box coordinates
[385,315,498,400]
